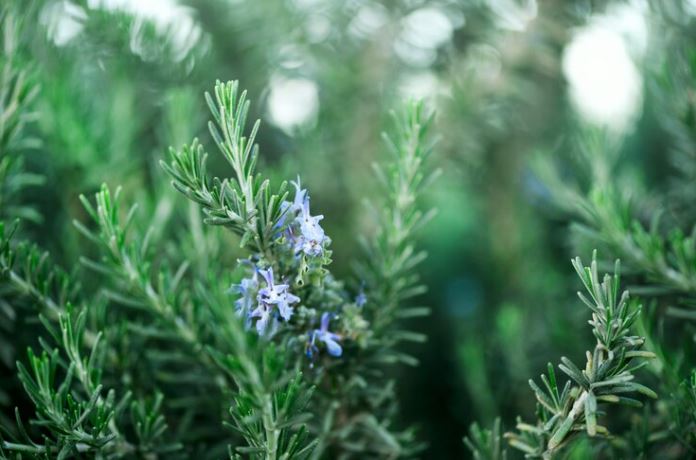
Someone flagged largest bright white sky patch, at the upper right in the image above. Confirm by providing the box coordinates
[563,2,647,131]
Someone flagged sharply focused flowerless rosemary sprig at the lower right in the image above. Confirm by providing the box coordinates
[465,253,657,458]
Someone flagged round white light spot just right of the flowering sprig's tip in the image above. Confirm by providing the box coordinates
[268,77,319,134]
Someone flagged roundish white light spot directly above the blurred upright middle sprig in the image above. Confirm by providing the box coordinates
[394,7,454,67]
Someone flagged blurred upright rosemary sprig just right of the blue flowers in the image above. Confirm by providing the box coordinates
[356,103,435,342]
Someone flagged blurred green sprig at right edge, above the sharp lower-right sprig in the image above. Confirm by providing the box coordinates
[539,131,696,294]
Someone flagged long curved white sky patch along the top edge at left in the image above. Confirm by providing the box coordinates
[87,0,201,58]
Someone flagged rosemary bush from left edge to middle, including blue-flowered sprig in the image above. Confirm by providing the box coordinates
[0,74,431,460]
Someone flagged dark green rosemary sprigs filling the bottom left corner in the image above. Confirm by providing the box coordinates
[0,225,179,458]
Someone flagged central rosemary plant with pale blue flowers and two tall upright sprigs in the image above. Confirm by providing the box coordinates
[163,82,438,458]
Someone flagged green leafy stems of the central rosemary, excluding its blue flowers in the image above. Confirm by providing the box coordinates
[163,82,431,458]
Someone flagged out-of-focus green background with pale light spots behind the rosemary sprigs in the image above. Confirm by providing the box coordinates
[5,0,696,458]
